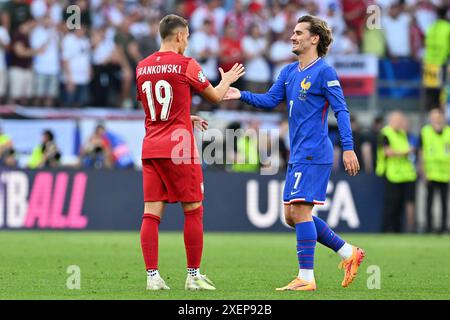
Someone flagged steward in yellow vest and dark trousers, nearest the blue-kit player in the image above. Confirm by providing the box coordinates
[376,111,417,232]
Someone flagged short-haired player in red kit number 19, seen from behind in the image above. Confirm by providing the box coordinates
[136,15,244,290]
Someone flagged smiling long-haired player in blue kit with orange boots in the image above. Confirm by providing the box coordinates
[224,15,365,291]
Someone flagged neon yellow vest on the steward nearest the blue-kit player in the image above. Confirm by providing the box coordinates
[376,126,417,183]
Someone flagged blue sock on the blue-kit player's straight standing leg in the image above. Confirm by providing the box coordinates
[295,221,317,270]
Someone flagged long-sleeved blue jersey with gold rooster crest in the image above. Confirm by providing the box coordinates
[241,57,353,164]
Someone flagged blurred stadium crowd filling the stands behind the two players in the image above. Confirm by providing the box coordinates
[0,0,444,110]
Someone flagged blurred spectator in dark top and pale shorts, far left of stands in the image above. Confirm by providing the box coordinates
[9,20,41,105]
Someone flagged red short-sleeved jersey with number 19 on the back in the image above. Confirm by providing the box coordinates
[136,51,210,159]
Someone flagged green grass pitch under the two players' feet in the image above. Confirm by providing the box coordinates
[0,231,450,300]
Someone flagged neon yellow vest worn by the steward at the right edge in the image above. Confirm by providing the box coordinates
[421,125,450,183]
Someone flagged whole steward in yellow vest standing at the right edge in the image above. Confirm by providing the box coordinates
[420,109,450,233]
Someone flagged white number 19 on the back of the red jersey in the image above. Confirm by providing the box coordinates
[142,80,173,121]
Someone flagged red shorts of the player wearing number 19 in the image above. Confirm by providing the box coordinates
[142,159,203,203]
